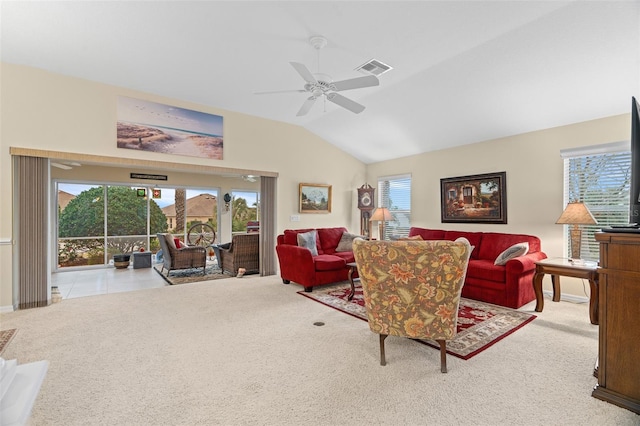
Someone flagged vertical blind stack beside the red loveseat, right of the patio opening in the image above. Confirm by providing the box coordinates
[260,176,277,276]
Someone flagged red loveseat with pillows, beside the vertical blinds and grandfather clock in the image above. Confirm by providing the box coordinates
[276,227,357,292]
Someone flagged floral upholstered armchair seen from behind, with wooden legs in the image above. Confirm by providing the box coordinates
[353,239,471,373]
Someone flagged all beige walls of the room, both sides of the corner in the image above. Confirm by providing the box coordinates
[0,64,630,309]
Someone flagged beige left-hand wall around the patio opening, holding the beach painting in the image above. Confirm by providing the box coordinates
[0,63,366,309]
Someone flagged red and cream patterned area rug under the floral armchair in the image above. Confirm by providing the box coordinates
[298,283,536,359]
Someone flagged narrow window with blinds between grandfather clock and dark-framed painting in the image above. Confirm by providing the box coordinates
[378,175,411,240]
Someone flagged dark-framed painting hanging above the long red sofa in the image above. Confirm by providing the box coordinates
[440,172,507,224]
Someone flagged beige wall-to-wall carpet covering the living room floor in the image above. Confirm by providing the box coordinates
[0,275,640,426]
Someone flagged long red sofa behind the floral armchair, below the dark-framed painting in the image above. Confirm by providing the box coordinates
[409,227,547,309]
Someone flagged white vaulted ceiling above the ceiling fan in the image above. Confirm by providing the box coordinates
[0,0,640,163]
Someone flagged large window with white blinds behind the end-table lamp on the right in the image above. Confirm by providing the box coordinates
[561,142,631,261]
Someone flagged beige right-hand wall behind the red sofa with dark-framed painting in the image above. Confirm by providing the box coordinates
[367,114,631,297]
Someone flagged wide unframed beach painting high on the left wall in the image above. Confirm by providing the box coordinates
[117,96,223,160]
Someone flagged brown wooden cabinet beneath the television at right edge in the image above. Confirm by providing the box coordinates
[592,232,640,414]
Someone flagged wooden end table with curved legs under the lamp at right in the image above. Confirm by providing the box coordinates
[533,257,598,325]
